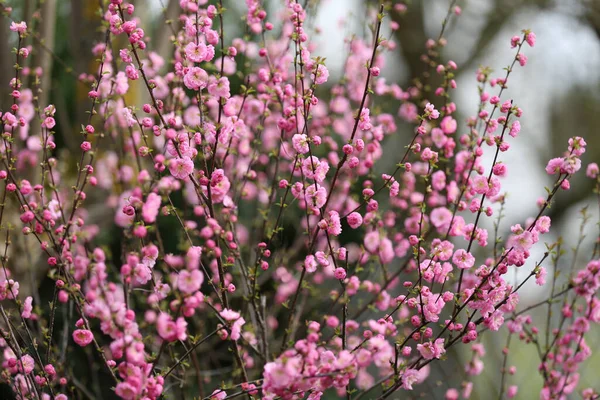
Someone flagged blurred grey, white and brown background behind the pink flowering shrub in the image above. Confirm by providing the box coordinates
[0,0,600,399]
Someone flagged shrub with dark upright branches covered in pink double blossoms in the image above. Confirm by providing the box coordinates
[0,0,600,400]
